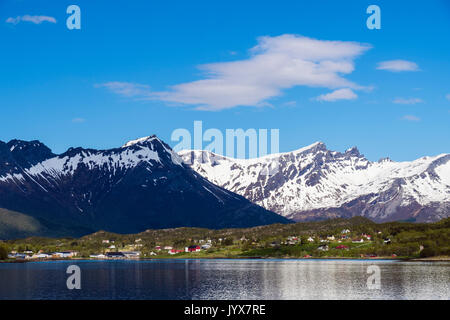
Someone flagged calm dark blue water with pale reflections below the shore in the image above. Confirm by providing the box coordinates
[0,259,450,300]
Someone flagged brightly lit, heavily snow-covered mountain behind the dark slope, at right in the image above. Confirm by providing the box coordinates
[179,142,450,222]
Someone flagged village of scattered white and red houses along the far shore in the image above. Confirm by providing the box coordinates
[3,228,397,261]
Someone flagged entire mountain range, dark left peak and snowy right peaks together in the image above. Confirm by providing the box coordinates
[0,135,450,238]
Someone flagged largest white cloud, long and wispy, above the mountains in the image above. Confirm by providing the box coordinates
[96,34,370,110]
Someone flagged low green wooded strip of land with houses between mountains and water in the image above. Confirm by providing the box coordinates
[0,217,450,260]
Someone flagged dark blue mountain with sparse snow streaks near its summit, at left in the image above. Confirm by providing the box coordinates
[0,136,288,238]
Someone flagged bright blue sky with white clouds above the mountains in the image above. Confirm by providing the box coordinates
[0,0,450,161]
